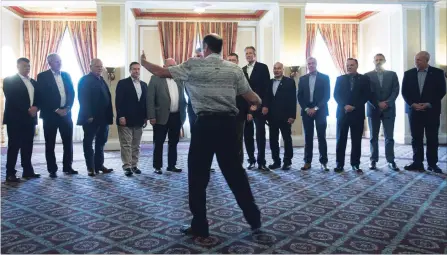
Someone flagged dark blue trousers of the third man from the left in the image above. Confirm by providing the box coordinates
[82,121,109,171]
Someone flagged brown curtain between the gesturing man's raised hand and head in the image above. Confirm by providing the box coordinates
[158,21,197,64]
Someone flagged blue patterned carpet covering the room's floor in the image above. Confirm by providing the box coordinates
[1,140,447,254]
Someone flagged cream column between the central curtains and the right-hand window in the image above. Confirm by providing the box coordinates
[273,3,306,146]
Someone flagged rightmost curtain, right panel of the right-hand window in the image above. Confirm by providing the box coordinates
[319,24,358,74]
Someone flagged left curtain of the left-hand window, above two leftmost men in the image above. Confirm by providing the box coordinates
[23,20,66,79]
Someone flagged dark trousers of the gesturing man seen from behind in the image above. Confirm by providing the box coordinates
[188,116,261,234]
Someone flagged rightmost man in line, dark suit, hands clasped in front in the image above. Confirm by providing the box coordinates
[402,51,446,173]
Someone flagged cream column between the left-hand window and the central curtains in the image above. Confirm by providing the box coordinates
[96,3,128,151]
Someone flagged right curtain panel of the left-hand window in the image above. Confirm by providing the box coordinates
[68,21,97,75]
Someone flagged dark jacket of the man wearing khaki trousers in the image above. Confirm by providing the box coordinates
[115,77,147,127]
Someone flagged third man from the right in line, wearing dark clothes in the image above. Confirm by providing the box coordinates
[334,58,375,173]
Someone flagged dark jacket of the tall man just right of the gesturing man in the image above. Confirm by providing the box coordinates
[242,61,270,108]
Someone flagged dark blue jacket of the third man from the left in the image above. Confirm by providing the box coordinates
[77,73,113,125]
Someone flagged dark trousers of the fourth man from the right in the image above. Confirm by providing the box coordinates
[302,113,328,164]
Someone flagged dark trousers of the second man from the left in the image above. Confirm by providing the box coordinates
[43,115,73,173]
